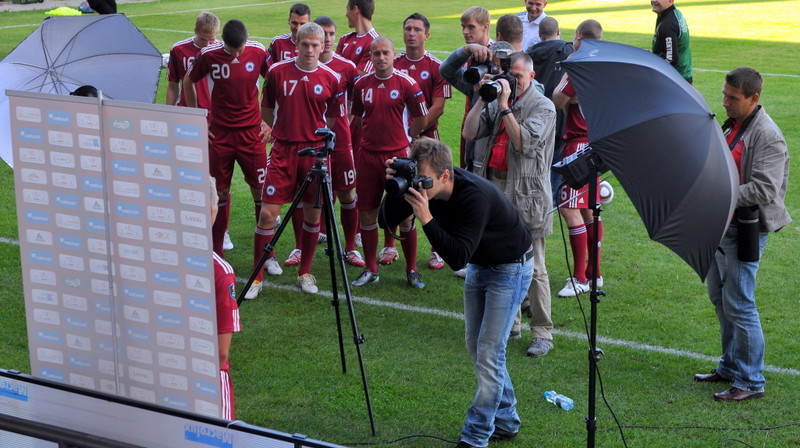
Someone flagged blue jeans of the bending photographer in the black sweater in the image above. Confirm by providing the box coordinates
[461,254,533,447]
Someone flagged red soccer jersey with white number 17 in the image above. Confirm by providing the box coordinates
[261,59,344,143]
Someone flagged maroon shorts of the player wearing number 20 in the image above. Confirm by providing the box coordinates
[208,124,267,190]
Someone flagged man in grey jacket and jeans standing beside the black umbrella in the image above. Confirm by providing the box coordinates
[694,67,791,401]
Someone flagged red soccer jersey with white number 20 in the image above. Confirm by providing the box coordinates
[189,40,267,128]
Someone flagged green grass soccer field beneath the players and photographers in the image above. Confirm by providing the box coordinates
[0,0,800,448]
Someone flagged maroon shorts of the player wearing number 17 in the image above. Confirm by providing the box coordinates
[261,140,319,204]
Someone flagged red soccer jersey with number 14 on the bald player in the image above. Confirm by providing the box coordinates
[352,70,428,151]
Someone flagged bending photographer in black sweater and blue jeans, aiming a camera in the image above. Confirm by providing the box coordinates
[379,138,536,448]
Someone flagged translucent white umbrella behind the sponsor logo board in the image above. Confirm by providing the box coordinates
[0,14,162,164]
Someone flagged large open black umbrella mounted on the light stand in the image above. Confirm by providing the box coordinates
[561,39,739,280]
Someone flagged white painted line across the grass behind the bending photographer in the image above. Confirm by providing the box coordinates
[0,231,800,376]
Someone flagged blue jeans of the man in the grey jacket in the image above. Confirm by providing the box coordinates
[706,225,767,392]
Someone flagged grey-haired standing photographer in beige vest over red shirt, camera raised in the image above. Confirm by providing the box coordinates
[463,50,556,356]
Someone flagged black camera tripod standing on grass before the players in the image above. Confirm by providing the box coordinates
[236,128,376,436]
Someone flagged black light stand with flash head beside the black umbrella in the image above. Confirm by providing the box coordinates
[553,146,608,448]
